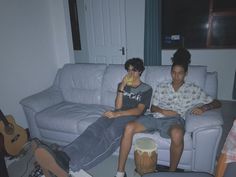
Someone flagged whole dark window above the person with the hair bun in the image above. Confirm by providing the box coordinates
[162,0,236,49]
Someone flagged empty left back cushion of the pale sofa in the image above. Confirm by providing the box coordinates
[60,64,106,104]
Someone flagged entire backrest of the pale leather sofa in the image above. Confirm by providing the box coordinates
[54,64,217,106]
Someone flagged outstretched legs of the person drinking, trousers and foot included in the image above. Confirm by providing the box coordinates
[35,116,136,177]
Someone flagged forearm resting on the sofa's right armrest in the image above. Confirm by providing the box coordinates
[192,99,221,115]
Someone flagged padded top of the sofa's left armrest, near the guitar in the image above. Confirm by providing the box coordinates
[20,87,63,112]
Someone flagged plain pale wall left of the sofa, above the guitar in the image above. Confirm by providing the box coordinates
[0,0,73,127]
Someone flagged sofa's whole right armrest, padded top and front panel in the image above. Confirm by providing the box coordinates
[185,109,223,174]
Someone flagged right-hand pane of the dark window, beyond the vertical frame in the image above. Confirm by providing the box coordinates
[207,0,236,48]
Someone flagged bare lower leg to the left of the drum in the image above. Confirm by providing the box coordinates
[117,122,145,172]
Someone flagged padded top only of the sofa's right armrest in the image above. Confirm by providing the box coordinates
[185,109,223,133]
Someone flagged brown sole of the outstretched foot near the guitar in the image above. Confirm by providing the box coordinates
[35,147,68,177]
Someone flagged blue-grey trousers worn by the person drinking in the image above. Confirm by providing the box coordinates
[63,116,137,171]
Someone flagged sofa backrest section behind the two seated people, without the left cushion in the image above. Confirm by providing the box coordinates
[101,64,217,106]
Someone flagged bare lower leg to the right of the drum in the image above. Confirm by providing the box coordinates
[169,126,184,171]
